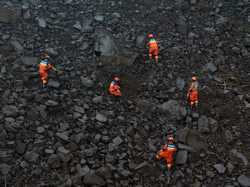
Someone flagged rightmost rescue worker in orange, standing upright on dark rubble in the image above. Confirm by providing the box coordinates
[187,76,199,108]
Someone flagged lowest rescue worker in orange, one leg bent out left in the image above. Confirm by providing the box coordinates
[156,135,177,172]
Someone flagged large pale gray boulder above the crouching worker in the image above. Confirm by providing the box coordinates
[95,29,120,56]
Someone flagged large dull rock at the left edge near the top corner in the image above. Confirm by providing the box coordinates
[0,7,18,23]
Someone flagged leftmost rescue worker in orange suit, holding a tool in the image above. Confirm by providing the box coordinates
[39,53,57,88]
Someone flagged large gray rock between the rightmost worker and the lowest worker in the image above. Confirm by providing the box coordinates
[158,100,187,120]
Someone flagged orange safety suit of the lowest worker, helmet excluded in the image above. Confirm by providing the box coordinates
[156,144,177,169]
